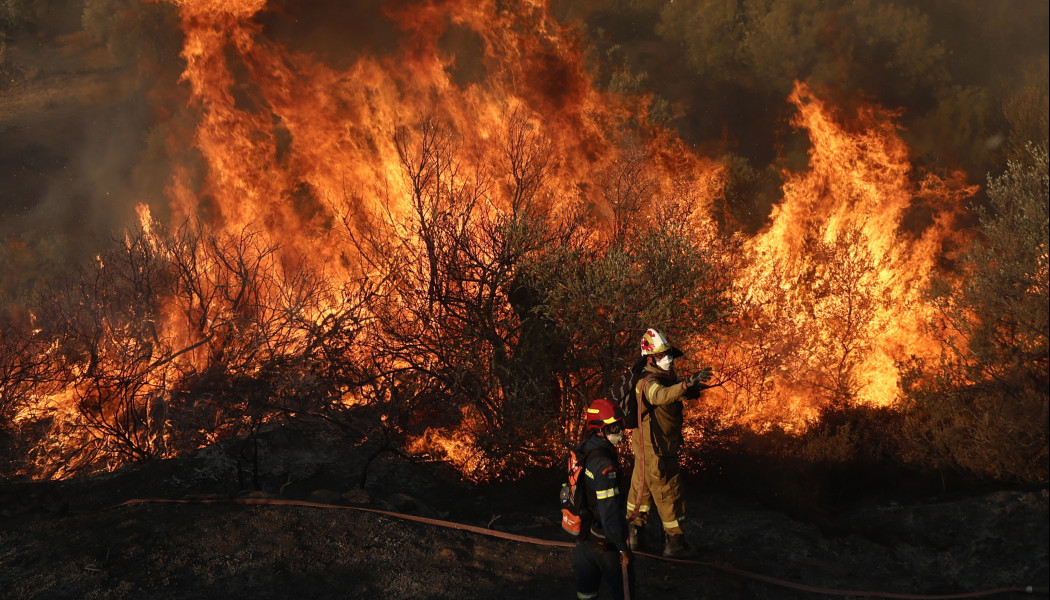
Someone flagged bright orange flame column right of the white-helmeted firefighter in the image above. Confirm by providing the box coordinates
[713,84,977,428]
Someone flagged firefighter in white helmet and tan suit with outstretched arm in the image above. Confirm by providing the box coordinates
[627,329,711,558]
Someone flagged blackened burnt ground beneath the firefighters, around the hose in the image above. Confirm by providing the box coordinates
[0,430,1050,600]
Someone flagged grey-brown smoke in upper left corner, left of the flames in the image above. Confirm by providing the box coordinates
[0,0,181,279]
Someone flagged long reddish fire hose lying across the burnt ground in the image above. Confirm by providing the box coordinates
[106,498,1050,600]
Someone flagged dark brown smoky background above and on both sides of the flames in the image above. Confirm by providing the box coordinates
[0,0,1050,279]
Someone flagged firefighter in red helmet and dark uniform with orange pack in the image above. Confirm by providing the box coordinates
[572,398,634,600]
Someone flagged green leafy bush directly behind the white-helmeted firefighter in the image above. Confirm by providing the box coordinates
[529,222,730,407]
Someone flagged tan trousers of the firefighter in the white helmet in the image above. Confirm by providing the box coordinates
[627,423,686,536]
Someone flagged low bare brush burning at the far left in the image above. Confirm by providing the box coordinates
[0,216,380,476]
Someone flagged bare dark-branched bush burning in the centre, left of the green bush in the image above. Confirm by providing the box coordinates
[347,120,575,475]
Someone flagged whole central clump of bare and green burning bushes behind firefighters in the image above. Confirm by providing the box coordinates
[347,115,725,479]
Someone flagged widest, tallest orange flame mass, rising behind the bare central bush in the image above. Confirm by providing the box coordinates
[159,0,720,470]
